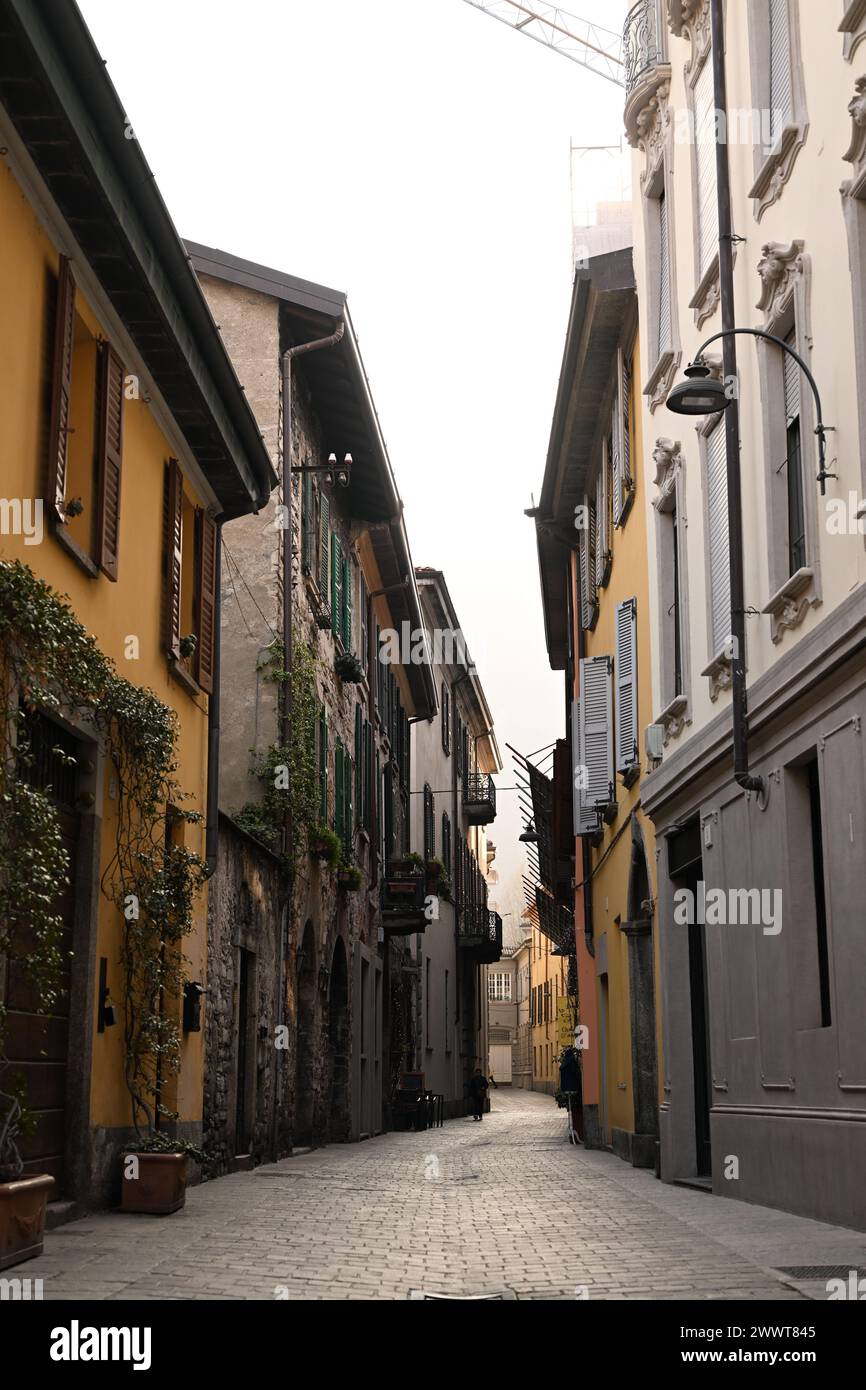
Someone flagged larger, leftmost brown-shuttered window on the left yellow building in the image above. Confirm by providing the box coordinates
[46,256,125,580]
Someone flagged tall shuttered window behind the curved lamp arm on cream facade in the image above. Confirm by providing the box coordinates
[758,251,820,642]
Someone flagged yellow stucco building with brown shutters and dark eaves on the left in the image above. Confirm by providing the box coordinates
[0,3,275,1204]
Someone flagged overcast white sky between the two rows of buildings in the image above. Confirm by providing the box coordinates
[79,0,626,906]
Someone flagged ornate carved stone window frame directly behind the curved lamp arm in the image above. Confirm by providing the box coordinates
[755,239,822,642]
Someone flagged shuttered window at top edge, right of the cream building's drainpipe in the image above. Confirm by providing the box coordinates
[746,0,809,220]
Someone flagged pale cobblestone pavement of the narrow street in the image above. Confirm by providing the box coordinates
[22,1087,866,1300]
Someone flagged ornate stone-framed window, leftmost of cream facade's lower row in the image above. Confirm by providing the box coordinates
[652,439,692,745]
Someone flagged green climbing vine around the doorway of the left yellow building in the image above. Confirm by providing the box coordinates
[0,560,206,1176]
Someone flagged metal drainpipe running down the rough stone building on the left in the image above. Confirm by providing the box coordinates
[271,318,346,1158]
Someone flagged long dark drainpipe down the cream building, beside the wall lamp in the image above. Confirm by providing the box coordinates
[710,0,763,791]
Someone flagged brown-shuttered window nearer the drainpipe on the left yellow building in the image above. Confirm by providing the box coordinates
[161,459,218,694]
